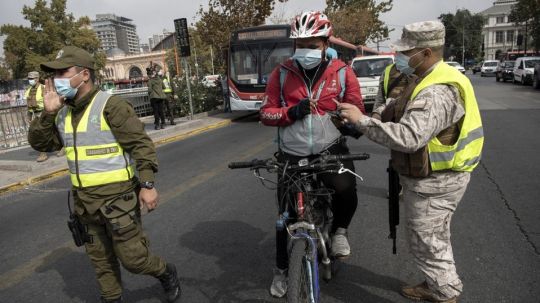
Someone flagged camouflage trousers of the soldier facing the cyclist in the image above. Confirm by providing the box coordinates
[401,173,470,300]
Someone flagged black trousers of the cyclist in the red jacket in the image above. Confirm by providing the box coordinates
[276,141,358,269]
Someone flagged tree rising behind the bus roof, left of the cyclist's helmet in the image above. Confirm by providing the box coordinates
[194,0,287,71]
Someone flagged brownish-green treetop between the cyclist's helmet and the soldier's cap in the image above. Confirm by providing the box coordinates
[325,0,393,45]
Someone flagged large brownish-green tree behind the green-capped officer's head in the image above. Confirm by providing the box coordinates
[0,0,106,79]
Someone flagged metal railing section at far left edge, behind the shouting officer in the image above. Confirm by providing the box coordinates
[0,105,29,150]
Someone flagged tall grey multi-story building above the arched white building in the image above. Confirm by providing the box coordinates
[92,14,140,54]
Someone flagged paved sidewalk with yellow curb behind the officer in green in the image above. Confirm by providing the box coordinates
[0,111,254,194]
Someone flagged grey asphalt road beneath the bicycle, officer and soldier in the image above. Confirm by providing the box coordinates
[0,75,540,303]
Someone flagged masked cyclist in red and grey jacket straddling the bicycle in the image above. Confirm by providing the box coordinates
[260,12,365,297]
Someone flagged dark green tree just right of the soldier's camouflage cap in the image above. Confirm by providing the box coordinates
[439,9,484,66]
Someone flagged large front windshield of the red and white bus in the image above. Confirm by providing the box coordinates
[230,42,292,85]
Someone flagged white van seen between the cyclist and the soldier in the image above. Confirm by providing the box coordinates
[351,55,394,104]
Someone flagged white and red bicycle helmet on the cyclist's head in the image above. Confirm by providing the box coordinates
[290,11,332,39]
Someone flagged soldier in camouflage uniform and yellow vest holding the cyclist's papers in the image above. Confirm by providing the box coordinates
[340,21,483,302]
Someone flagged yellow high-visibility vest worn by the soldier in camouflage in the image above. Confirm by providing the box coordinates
[411,62,484,172]
